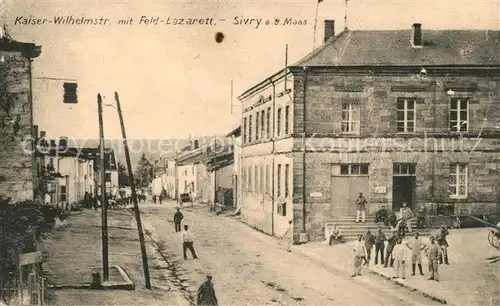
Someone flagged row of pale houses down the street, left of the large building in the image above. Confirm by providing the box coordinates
[152,127,241,207]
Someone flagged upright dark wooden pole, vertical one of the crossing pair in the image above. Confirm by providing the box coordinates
[97,94,109,281]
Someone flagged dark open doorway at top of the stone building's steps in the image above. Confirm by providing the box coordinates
[392,164,416,211]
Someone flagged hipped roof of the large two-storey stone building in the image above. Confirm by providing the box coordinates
[293,29,500,66]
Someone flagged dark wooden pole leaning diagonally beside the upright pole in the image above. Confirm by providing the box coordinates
[115,92,151,289]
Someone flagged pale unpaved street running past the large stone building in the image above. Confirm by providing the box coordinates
[141,202,437,305]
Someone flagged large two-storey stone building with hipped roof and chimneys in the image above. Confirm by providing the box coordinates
[239,21,500,241]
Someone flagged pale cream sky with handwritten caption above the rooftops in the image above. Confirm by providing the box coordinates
[0,0,500,139]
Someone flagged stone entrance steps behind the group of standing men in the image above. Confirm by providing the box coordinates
[326,216,431,240]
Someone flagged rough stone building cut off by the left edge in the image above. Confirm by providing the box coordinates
[0,36,41,201]
